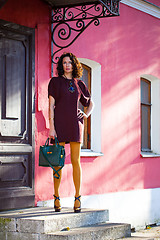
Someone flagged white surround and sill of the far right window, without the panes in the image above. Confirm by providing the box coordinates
[140,74,160,157]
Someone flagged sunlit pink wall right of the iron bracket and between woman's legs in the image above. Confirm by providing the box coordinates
[49,4,160,199]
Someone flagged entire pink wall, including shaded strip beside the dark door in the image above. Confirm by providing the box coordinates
[0,0,160,205]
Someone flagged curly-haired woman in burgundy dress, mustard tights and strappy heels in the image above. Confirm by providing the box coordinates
[48,53,94,213]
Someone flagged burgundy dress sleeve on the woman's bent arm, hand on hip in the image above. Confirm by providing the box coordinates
[78,80,91,107]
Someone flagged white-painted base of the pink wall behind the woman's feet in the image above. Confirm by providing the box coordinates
[37,188,160,229]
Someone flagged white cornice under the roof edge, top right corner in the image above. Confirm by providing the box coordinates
[121,0,160,18]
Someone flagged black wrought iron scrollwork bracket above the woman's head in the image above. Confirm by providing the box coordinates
[52,0,120,63]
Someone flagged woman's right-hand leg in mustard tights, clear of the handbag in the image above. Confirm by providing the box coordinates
[70,142,81,208]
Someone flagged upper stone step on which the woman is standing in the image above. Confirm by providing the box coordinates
[0,207,109,234]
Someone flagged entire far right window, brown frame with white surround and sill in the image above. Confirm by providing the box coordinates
[141,74,160,157]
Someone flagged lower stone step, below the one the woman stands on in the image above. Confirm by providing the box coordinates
[0,223,131,240]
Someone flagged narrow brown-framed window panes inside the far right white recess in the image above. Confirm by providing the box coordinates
[141,78,151,152]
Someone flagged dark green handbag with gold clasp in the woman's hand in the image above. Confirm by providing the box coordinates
[39,137,65,179]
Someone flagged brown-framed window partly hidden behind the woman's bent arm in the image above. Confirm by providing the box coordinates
[79,64,91,149]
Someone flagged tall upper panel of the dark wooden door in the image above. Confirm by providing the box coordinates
[0,39,26,136]
